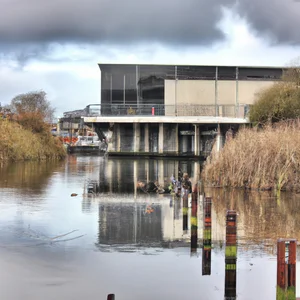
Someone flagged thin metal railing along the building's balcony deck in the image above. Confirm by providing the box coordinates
[85,104,249,118]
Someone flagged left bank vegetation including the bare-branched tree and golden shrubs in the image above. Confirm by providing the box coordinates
[0,91,66,163]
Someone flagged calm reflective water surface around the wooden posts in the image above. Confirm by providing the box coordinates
[0,156,300,300]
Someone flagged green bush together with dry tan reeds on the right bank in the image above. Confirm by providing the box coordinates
[202,62,300,193]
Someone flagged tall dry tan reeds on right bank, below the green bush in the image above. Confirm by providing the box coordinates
[202,120,300,190]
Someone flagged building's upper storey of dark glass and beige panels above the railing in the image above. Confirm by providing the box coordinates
[99,64,283,115]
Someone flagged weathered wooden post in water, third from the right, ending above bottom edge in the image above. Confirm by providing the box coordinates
[202,197,212,275]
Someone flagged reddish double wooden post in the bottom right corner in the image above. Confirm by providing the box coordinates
[276,239,297,300]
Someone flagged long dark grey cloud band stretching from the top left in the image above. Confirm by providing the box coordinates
[0,0,233,45]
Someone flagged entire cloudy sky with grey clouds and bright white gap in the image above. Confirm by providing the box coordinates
[0,0,300,115]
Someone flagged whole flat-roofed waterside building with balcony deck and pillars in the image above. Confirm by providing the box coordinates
[84,64,284,158]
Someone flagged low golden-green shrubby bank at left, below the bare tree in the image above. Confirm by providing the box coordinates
[0,120,66,162]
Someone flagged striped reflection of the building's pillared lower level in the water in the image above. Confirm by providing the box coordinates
[85,159,199,196]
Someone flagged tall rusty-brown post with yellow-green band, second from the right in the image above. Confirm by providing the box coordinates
[225,210,237,300]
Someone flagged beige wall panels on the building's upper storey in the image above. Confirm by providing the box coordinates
[165,80,274,108]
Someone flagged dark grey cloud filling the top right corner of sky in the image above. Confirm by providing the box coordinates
[236,0,300,45]
